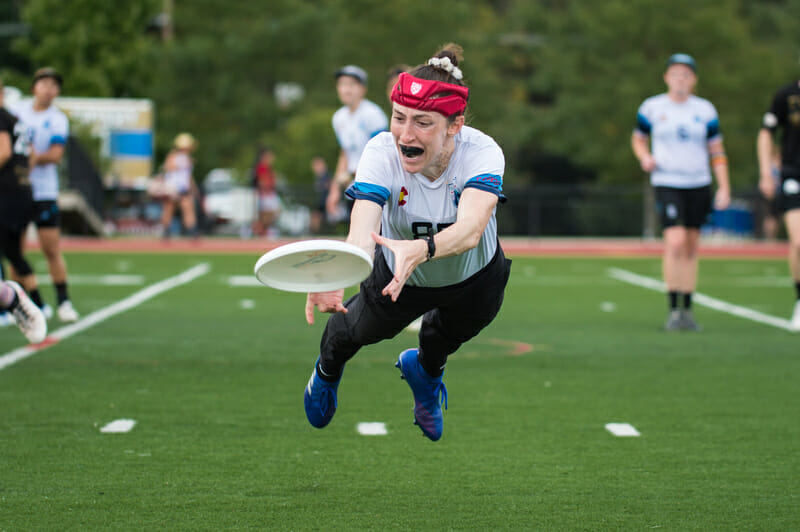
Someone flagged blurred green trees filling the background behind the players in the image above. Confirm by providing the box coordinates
[9,0,800,187]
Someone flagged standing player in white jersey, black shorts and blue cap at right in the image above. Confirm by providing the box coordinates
[631,54,730,331]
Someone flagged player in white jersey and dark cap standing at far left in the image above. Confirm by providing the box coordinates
[11,67,78,322]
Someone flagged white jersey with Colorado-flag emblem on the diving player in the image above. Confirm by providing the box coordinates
[347,126,505,287]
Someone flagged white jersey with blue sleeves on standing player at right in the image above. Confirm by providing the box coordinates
[636,94,722,188]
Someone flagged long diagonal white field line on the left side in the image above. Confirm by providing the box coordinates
[0,263,211,370]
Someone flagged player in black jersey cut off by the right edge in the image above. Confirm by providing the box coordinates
[758,81,800,331]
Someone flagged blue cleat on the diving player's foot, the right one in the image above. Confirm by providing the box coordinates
[395,349,447,441]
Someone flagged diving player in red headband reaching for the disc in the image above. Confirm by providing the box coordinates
[304,44,511,441]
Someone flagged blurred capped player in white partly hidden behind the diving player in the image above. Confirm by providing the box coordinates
[326,65,389,221]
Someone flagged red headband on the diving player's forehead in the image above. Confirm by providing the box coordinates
[392,72,469,117]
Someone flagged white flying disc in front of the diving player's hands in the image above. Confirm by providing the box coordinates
[255,240,372,292]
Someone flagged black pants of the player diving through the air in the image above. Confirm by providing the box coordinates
[320,244,511,366]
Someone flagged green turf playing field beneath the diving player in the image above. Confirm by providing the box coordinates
[0,242,800,530]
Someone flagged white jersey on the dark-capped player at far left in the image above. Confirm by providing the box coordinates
[14,100,69,201]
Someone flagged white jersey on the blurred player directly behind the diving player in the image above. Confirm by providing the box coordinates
[333,100,389,174]
